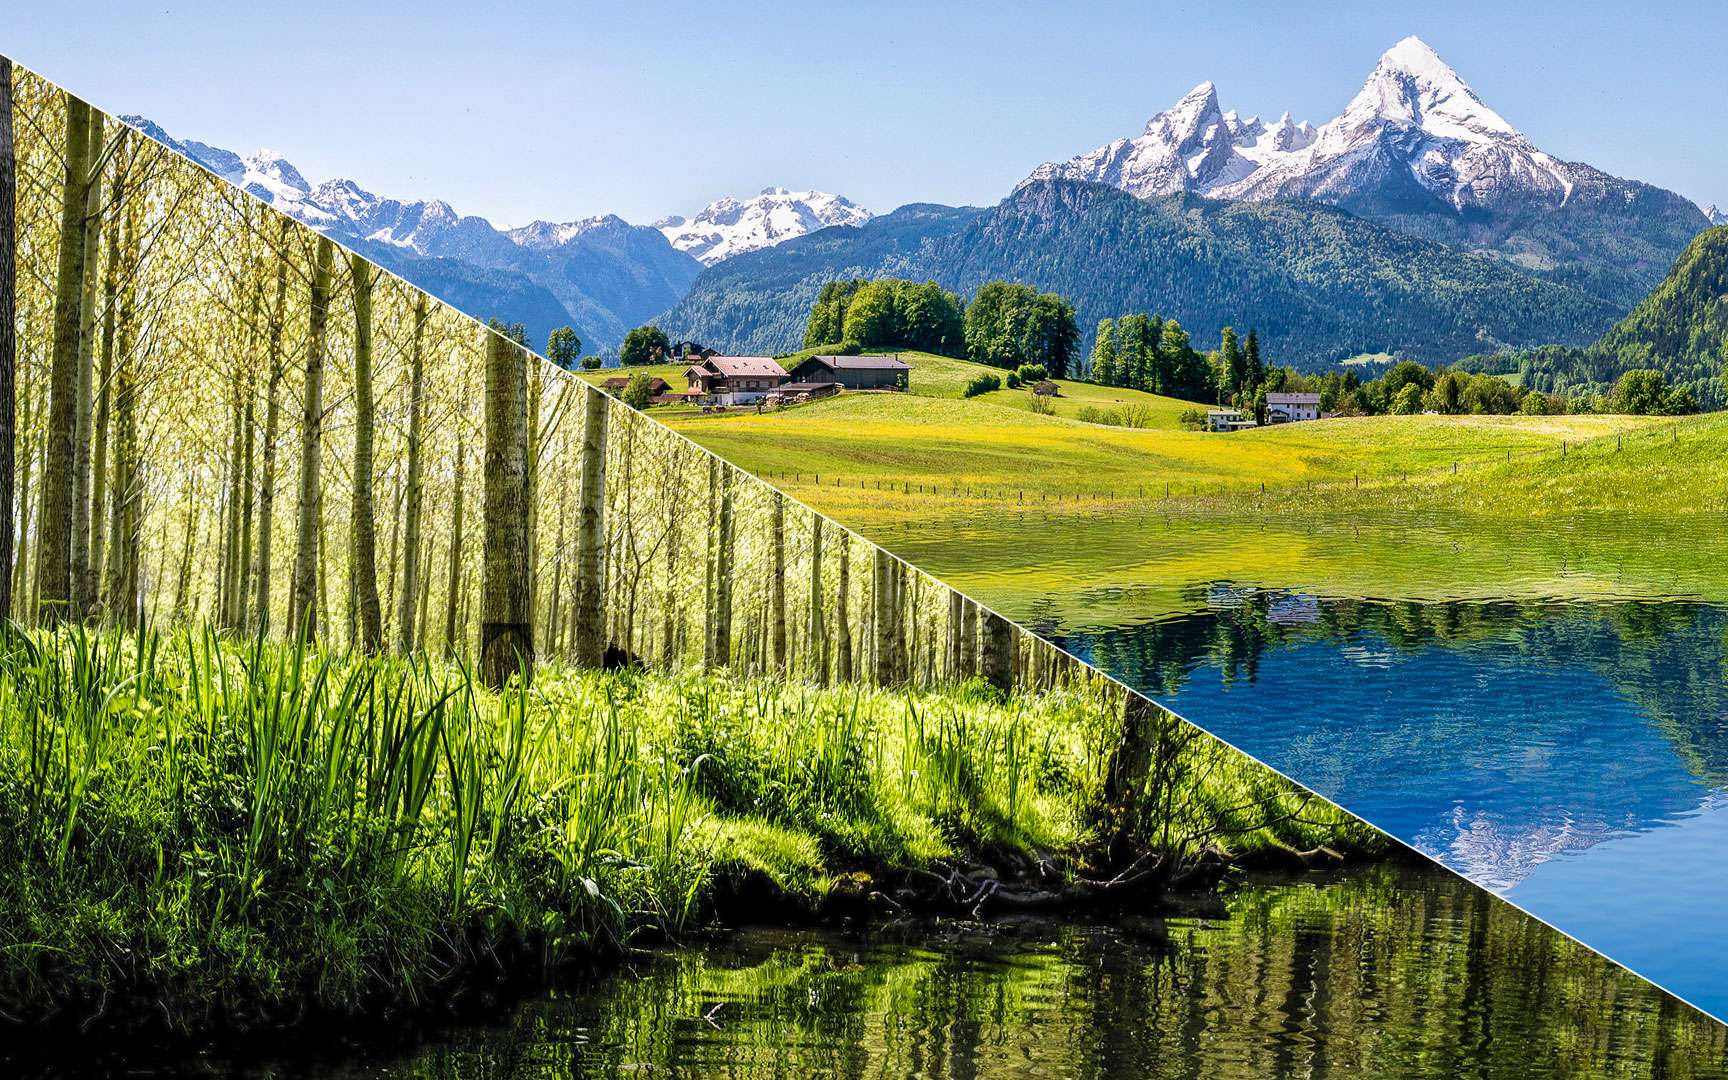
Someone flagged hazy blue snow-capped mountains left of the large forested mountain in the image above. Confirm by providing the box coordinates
[121,116,869,351]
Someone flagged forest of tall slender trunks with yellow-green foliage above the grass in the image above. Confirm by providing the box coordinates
[0,65,1061,688]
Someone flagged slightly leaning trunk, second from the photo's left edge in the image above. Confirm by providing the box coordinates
[36,93,95,622]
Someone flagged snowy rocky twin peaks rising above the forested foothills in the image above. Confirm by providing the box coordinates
[1030,38,1714,308]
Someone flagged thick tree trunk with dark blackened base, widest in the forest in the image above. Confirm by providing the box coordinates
[479,330,534,688]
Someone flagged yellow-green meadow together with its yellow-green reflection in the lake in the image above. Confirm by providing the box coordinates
[625,356,1728,626]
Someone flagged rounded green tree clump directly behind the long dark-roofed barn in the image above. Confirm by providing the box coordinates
[804,278,966,356]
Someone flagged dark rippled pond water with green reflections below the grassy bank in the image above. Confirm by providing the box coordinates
[196,867,1728,1080]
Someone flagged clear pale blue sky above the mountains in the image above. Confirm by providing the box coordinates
[0,0,1728,225]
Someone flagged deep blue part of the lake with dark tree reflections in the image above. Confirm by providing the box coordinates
[1068,597,1728,1016]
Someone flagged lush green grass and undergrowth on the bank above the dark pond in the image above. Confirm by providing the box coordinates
[0,631,1375,1026]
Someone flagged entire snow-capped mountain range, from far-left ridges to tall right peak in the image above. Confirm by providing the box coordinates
[126,38,1728,370]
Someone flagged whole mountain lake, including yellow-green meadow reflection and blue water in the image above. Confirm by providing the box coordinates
[895,517,1728,1016]
